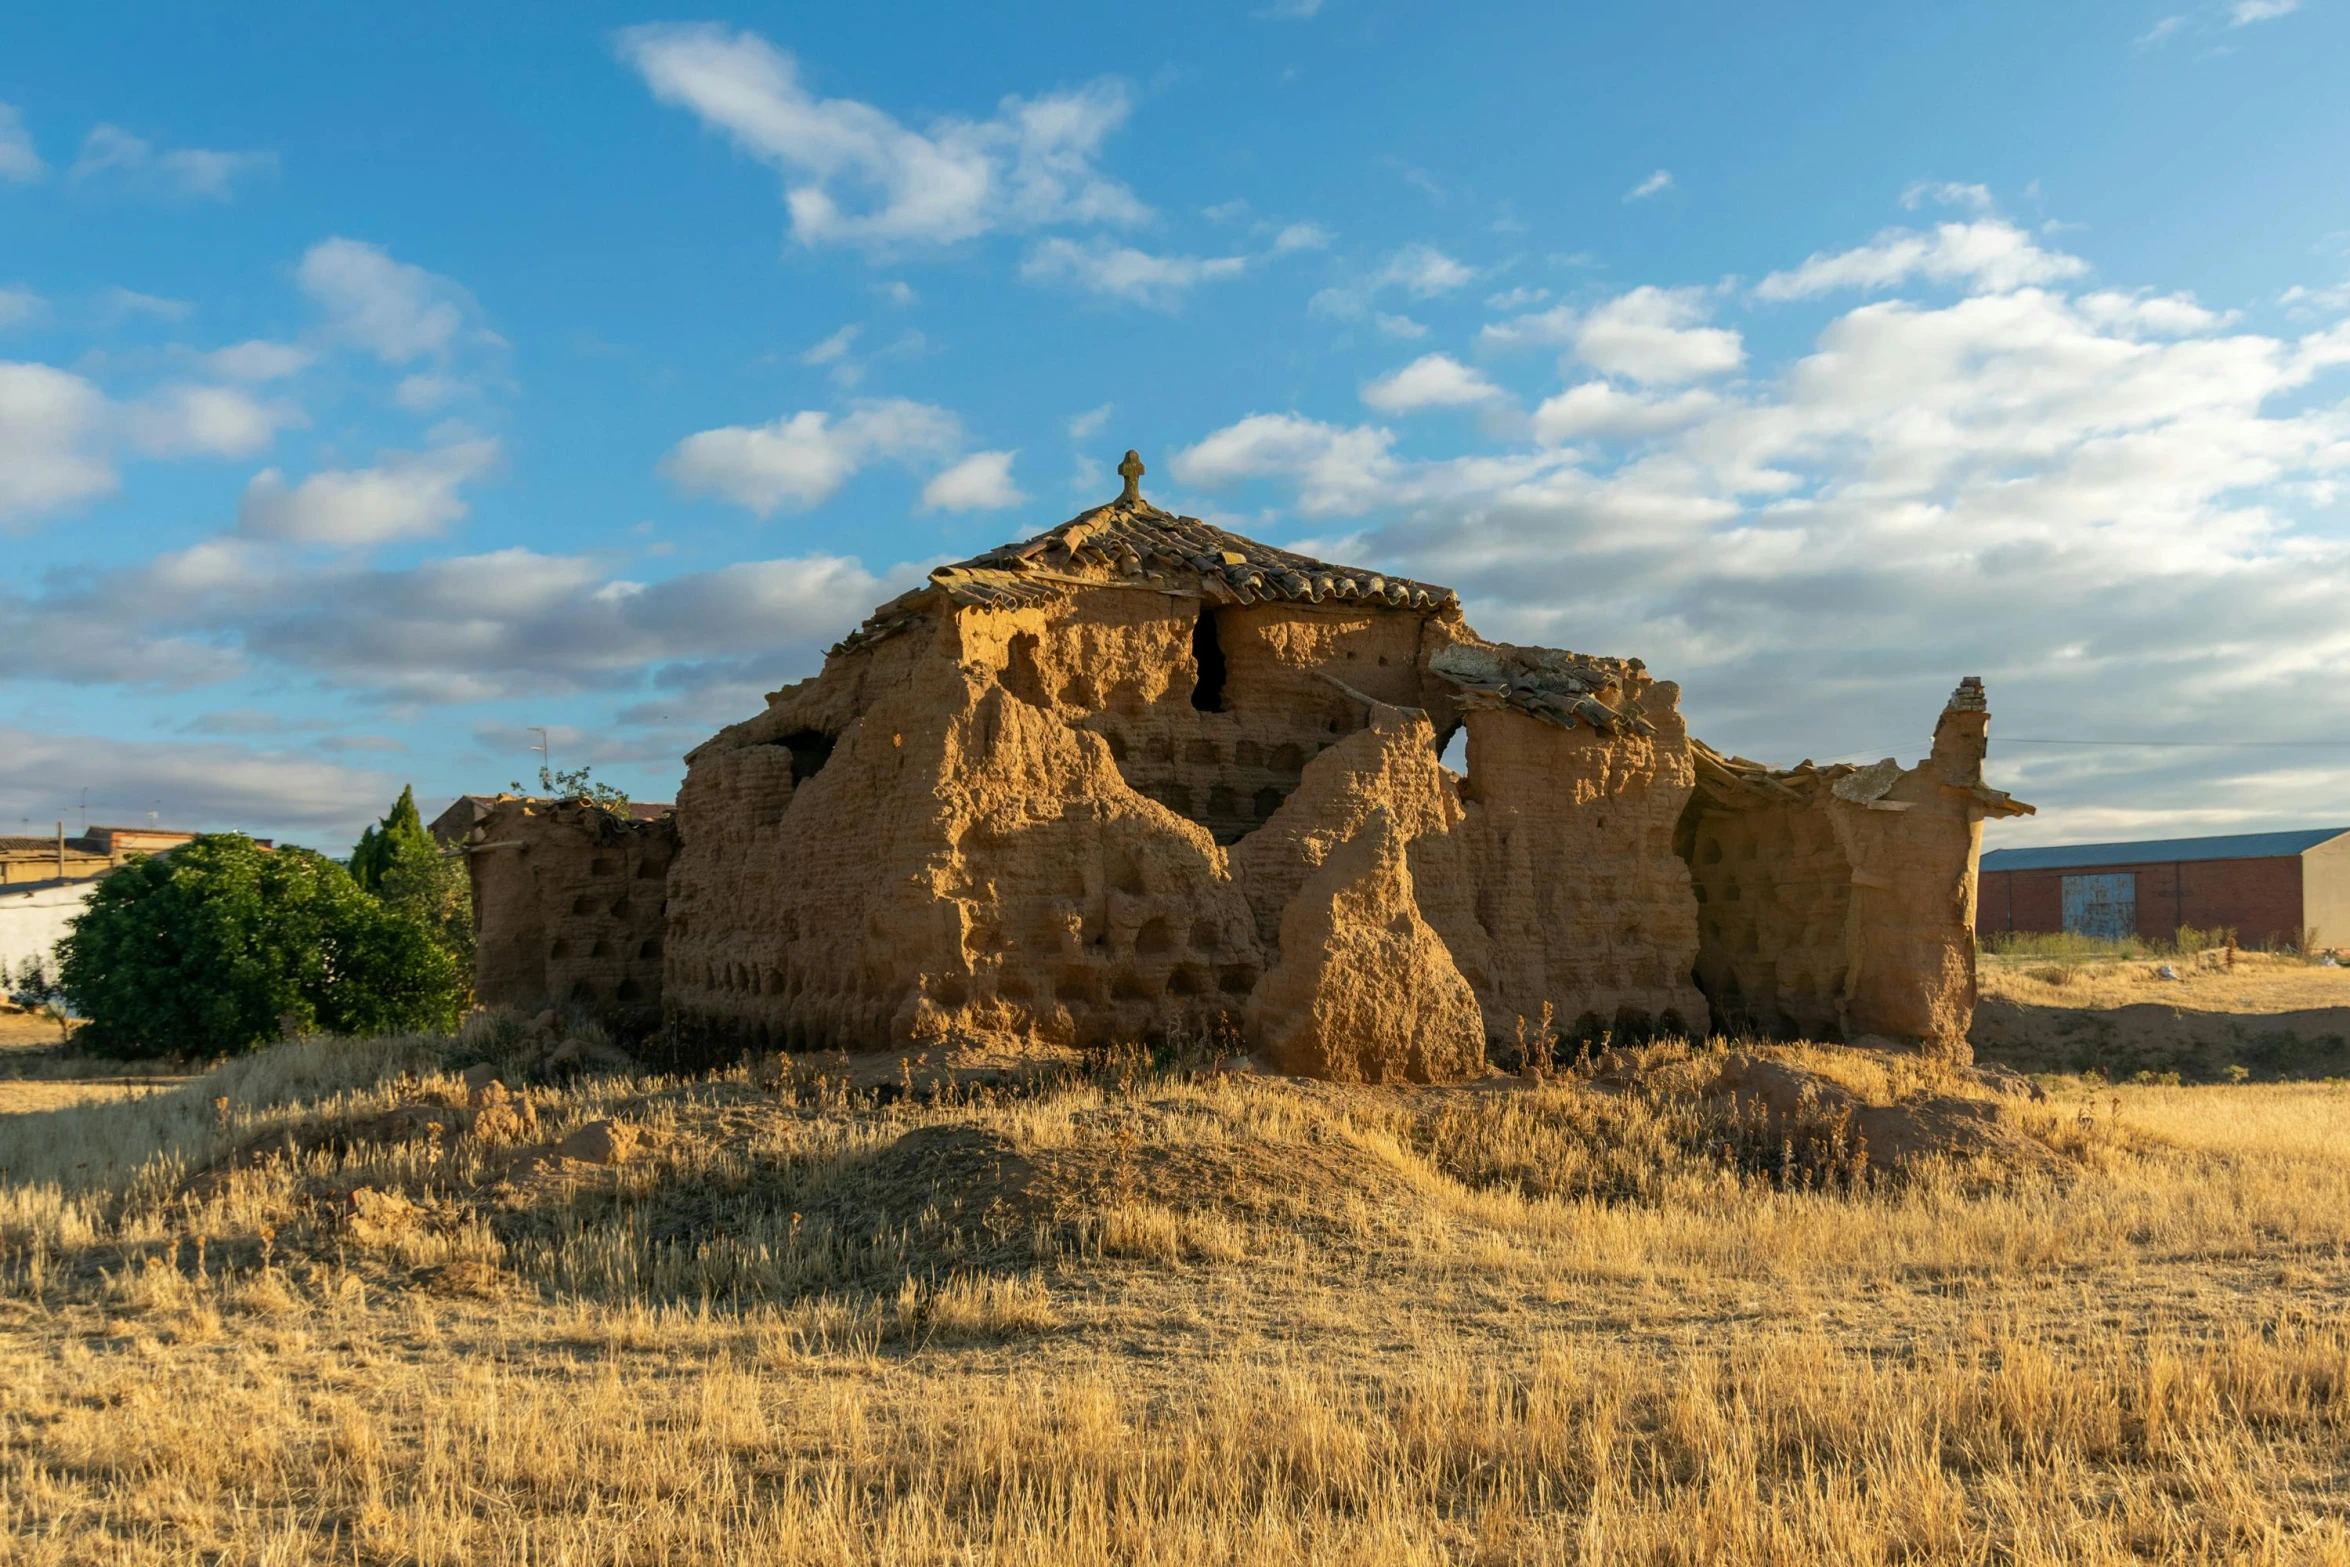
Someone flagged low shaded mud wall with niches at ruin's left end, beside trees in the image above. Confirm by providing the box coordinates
[465,799,677,1036]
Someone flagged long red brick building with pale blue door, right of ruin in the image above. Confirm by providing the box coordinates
[1974,827,2350,947]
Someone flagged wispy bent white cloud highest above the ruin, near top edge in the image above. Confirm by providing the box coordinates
[618,23,1147,247]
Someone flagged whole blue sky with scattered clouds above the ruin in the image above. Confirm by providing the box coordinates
[0,0,2350,848]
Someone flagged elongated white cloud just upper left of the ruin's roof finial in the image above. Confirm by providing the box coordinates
[660,397,964,517]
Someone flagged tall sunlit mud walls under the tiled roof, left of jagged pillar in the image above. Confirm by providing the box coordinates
[667,561,1448,1048]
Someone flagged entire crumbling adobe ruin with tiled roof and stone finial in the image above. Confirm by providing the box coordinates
[472,453,2028,1081]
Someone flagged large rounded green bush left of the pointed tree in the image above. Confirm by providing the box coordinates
[59,834,465,1055]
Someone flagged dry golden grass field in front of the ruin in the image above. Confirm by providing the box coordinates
[0,1041,2350,1565]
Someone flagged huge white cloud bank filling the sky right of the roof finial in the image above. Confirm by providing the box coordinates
[1177,254,2350,841]
